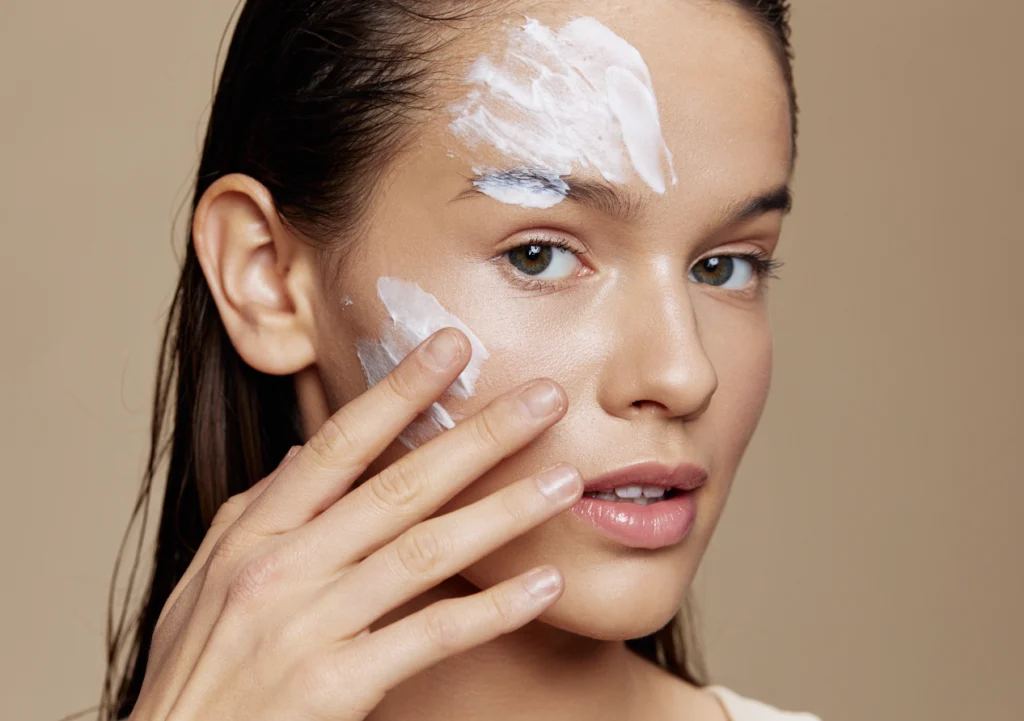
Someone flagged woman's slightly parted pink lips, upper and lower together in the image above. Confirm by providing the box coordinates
[571,462,708,548]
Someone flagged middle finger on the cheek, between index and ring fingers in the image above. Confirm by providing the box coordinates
[296,379,566,570]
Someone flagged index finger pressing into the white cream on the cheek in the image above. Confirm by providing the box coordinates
[239,328,470,536]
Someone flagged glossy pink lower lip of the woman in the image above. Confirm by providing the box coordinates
[571,491,696,548]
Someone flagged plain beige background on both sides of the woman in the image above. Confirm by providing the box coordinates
[0,0,1024,721]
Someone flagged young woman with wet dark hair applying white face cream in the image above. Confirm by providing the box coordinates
[104,0,813,721]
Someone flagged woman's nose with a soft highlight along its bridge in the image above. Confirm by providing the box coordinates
[598,278,718,420]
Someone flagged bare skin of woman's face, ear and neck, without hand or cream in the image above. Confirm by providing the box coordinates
[194,0,792,721]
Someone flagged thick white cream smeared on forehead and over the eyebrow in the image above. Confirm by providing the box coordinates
[450,17,678,208]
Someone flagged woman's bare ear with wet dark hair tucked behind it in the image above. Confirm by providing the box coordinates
[193,174,316,376]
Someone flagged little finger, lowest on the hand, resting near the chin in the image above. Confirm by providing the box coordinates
[326,566,563,695]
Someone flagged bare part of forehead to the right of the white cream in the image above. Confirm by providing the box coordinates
[622,0,793,190]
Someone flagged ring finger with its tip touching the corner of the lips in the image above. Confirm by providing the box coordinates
[316,464,583,635]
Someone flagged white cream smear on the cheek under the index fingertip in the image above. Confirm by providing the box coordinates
[355,277,490,449]
